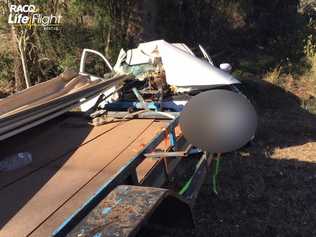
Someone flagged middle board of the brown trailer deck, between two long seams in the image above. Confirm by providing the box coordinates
[0,120,152,237]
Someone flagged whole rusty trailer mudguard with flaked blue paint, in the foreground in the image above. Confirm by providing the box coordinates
[65,185,194,237]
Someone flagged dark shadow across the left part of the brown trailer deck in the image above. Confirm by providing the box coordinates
[0,113,92,231]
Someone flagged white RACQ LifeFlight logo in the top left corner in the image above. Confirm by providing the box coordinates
[8,5,61,28]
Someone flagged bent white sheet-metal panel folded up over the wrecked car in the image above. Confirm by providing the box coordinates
[116,40,240,90]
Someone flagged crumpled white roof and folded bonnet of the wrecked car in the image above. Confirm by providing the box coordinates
[114,40,240,92]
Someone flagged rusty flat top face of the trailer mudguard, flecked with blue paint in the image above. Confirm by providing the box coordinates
[67,185,192,237]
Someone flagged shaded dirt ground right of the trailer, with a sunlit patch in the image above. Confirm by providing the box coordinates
[192,80,316,237]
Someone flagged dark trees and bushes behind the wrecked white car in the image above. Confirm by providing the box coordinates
[0,0,316,103]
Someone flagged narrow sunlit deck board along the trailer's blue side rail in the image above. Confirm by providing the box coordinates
[31,121,169,237]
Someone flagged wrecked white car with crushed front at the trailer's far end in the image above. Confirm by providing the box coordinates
[81,40,240,111]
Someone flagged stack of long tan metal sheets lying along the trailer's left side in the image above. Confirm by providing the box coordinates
[0,71,128,141]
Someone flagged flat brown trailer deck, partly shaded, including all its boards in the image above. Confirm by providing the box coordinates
[0,115,167,237]
